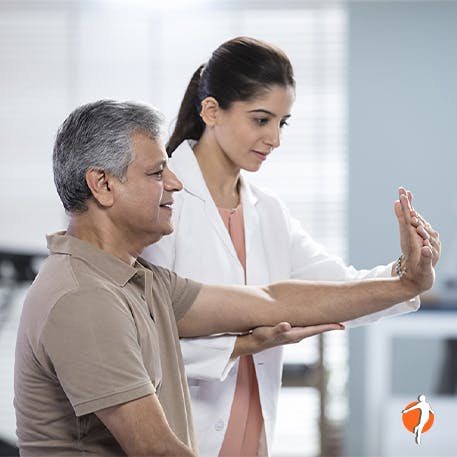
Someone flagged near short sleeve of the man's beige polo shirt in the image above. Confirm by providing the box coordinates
[41,288,155,416]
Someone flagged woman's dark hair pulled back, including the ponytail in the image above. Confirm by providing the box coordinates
[167,37,295,157]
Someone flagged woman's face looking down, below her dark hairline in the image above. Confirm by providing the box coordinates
[214,86,295,171]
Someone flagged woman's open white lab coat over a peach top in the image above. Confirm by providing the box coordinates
[144,141,419,457]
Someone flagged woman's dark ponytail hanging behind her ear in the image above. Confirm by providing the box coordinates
[166,65,205,157]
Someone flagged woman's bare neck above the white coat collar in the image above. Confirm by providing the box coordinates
[193,134,240,208]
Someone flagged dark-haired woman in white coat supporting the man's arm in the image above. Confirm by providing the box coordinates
[145,37,439,457]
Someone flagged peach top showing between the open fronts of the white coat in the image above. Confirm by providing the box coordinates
[218,203,263,457]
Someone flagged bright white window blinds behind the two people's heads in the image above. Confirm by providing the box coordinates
[0,0,347,456]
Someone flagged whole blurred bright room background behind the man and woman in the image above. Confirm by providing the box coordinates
[0,0,457,457]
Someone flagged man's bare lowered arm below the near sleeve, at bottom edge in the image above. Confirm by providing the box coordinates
[95,395,195,457]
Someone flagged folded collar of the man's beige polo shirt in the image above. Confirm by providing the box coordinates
[46,231,138,287]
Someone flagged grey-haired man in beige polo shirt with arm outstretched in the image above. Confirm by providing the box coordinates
[15,101,434,456]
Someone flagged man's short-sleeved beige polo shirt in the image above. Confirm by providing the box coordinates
[14,232,200,457]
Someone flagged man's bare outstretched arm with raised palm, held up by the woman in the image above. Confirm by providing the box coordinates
[178,194,434,336]
